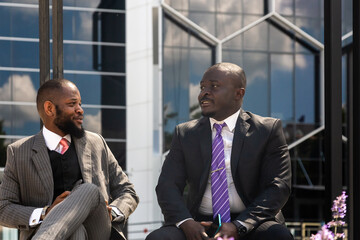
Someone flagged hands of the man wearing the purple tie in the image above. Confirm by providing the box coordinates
[180,220,239,240]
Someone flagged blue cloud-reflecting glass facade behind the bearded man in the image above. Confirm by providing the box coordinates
[0,0,126,167]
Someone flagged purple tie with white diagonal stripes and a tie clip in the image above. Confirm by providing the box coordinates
[211,123,230,222]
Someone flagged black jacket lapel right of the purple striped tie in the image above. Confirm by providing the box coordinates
[231,109,250,177]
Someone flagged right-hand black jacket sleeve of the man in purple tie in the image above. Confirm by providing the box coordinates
[237,119,291,227]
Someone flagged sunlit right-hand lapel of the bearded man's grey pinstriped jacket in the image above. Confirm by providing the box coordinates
[73,133,92,183]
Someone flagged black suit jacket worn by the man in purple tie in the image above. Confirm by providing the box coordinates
[156,110,291,227]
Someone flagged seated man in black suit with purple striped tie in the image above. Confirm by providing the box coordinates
[147,63,293,240]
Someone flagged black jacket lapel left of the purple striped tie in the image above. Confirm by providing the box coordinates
[197,118,212,190]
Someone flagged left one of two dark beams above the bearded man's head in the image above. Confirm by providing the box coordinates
[39,0,50,86]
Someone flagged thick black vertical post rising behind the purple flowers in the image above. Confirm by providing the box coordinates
[324,0,343,220]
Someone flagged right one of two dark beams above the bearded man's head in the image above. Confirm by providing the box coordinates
[52,0,64,79]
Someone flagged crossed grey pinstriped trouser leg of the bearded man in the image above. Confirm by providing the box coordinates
[33,183,111,240]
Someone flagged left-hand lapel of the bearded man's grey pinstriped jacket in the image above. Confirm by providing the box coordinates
[32,131,54,203]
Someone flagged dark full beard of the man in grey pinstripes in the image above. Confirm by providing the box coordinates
[54,106,85,138]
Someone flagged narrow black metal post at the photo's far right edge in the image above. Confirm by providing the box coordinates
[350,0,360,239]
